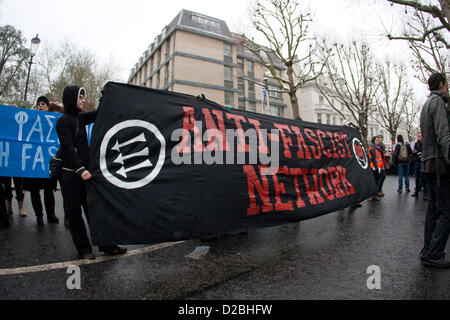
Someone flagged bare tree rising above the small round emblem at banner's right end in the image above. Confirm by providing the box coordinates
[316,41,378,146]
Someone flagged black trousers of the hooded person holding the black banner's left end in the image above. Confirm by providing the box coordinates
[59,170,114,255]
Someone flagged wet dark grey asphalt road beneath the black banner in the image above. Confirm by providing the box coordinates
[0,176,450,300]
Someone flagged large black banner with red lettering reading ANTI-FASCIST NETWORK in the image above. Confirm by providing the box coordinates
[88,83,376,245]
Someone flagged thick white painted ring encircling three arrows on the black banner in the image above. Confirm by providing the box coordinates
[100,120,166,190]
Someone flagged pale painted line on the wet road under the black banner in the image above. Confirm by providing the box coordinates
[0,241,185,276]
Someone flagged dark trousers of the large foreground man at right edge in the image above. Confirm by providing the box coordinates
[423,173,450,260]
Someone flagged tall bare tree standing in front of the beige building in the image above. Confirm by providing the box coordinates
[243,0,324,119]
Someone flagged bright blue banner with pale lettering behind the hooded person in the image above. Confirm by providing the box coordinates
[0,105,92,178]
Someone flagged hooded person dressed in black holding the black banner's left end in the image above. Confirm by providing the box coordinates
[56,86,127,260]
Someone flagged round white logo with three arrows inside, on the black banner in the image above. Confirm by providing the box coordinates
[100,120,166,190]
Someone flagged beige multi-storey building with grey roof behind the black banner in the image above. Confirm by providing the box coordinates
[128,10,292,118]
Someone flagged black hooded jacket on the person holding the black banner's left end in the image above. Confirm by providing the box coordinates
[56,86,97,176]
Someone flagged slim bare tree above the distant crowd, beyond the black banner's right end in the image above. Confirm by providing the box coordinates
[375,61,412,144]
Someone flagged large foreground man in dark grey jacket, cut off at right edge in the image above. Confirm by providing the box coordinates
[420,73,450,268]
